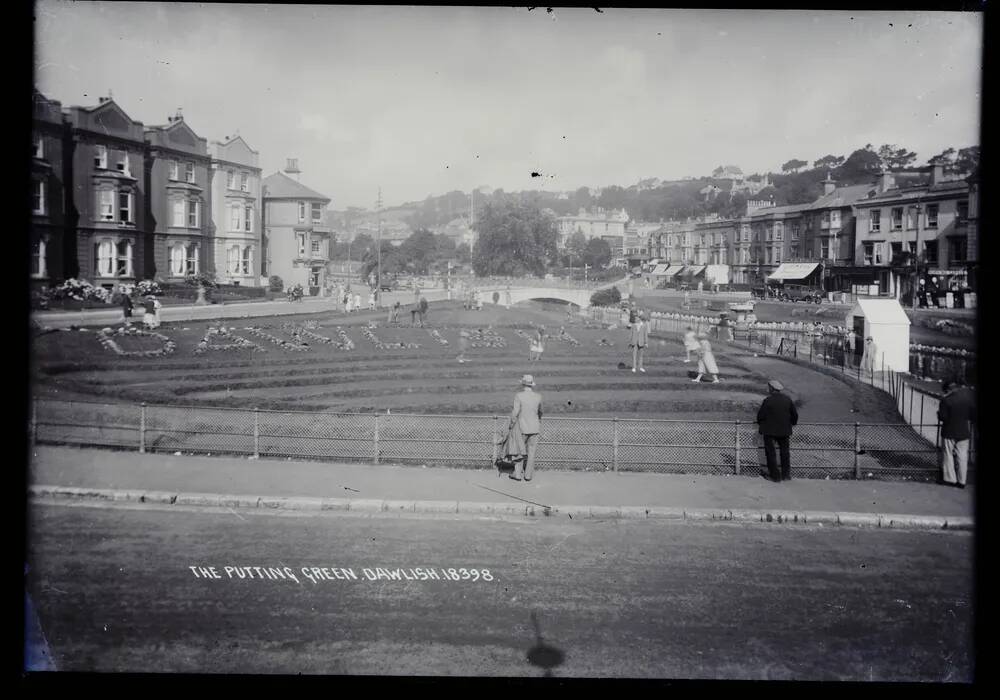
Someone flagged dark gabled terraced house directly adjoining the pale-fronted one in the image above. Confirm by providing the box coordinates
[144,110,215,281]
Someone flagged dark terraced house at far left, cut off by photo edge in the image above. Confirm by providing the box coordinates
[29,91,66,286]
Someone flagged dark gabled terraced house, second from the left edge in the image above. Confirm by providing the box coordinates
[64,97,146,288]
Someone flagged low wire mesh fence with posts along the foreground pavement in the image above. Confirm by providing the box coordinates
[30,394,956,481]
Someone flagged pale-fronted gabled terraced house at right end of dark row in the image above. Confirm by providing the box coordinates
[211,136,262,287]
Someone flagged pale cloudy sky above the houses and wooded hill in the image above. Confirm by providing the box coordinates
[35,0,983,209]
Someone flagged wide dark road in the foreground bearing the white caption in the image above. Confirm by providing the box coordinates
[28,504,973,681]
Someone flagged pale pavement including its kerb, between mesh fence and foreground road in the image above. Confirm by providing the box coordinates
[28,445,975,530]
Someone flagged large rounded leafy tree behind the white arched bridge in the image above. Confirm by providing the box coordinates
[472,201,559,277]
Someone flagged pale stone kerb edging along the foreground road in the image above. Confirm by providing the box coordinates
[28,485,974,531]
